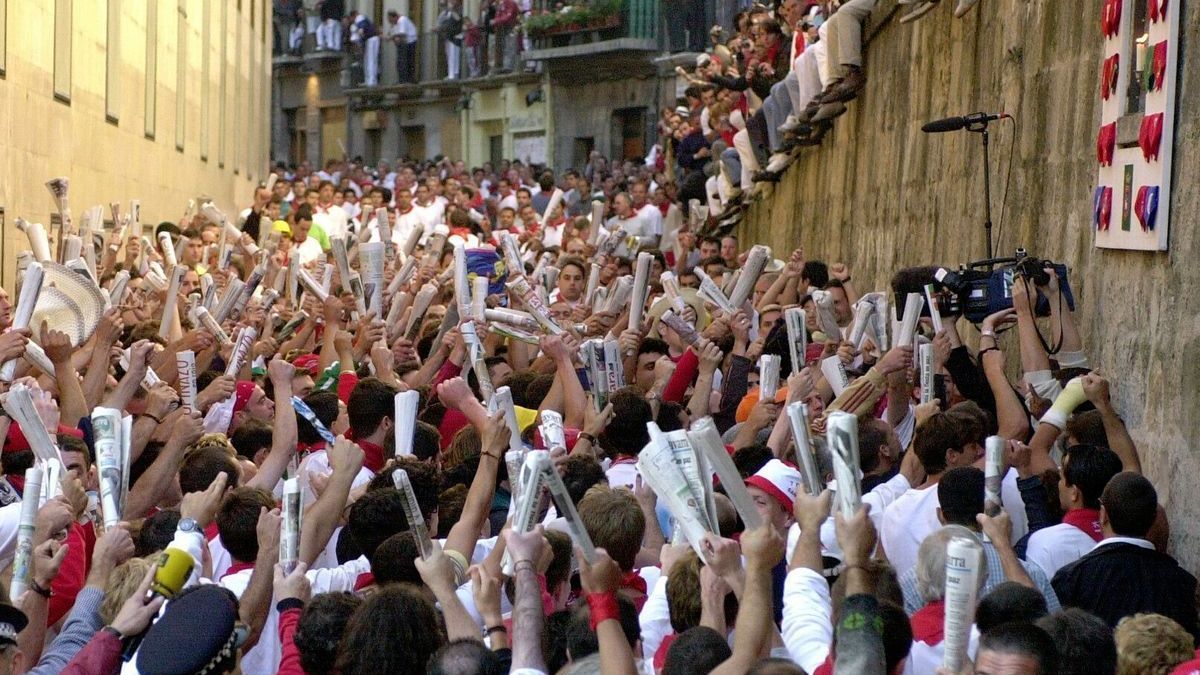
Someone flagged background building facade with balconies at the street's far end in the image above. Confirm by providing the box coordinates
[272,0,710,169]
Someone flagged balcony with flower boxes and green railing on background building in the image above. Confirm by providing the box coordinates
[521,0,662,61]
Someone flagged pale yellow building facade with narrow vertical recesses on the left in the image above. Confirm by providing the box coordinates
[0,0,271,288]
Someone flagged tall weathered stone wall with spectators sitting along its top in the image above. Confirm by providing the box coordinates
[740,0,1200,572]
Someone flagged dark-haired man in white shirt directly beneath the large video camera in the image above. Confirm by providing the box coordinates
[880,408,983,575]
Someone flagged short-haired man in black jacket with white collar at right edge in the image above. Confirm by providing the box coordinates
[1054,472,1198,637]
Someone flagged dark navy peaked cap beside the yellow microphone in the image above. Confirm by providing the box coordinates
[138,584,246,675]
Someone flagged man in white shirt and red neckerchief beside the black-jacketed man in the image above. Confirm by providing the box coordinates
[1025,446,1121,578]
